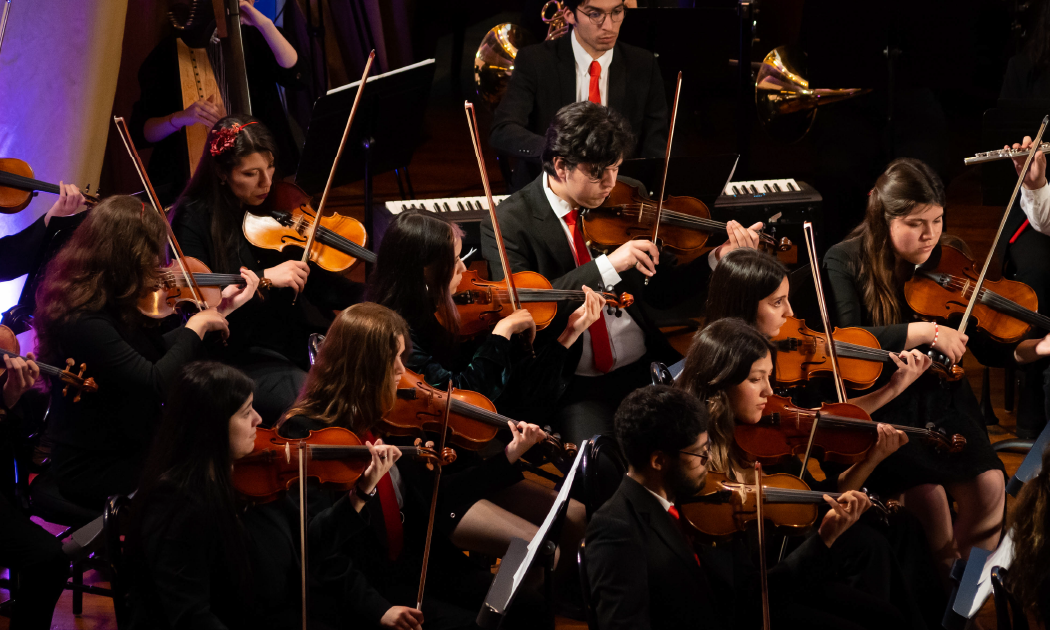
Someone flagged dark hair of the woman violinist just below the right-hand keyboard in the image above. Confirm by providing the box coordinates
[705,249,788,326]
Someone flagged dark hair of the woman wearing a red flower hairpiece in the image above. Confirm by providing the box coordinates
[172,116,277,273]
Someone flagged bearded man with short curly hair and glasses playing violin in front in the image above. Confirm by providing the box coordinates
[584,385,881,630]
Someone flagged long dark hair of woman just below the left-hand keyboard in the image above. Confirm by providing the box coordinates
[368,210,463,335]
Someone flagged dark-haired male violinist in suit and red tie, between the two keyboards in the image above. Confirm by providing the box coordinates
[481,101,762,444]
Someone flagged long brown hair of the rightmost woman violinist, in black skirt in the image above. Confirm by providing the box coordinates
[847,158,945,326]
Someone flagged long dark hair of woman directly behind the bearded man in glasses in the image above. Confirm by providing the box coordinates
[675,317,776,477]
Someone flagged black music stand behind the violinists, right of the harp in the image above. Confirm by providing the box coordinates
[295,59,436,235]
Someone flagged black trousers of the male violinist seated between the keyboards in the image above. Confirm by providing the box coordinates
[558,356,652,444]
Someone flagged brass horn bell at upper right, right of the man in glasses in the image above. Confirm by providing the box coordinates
[755,46,872,143]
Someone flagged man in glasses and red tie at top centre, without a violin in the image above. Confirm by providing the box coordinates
[489,0,668,190]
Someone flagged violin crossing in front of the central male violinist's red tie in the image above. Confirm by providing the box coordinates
[442,270,634,337]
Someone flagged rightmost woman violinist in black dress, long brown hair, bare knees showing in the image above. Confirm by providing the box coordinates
[824,159,1006,568]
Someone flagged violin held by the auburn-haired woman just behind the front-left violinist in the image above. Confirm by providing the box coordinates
[383,370,576,464]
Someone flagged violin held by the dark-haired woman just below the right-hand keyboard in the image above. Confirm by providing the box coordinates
[772,316,963,390]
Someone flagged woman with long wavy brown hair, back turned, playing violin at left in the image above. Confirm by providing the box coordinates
[35,195,258,510]
